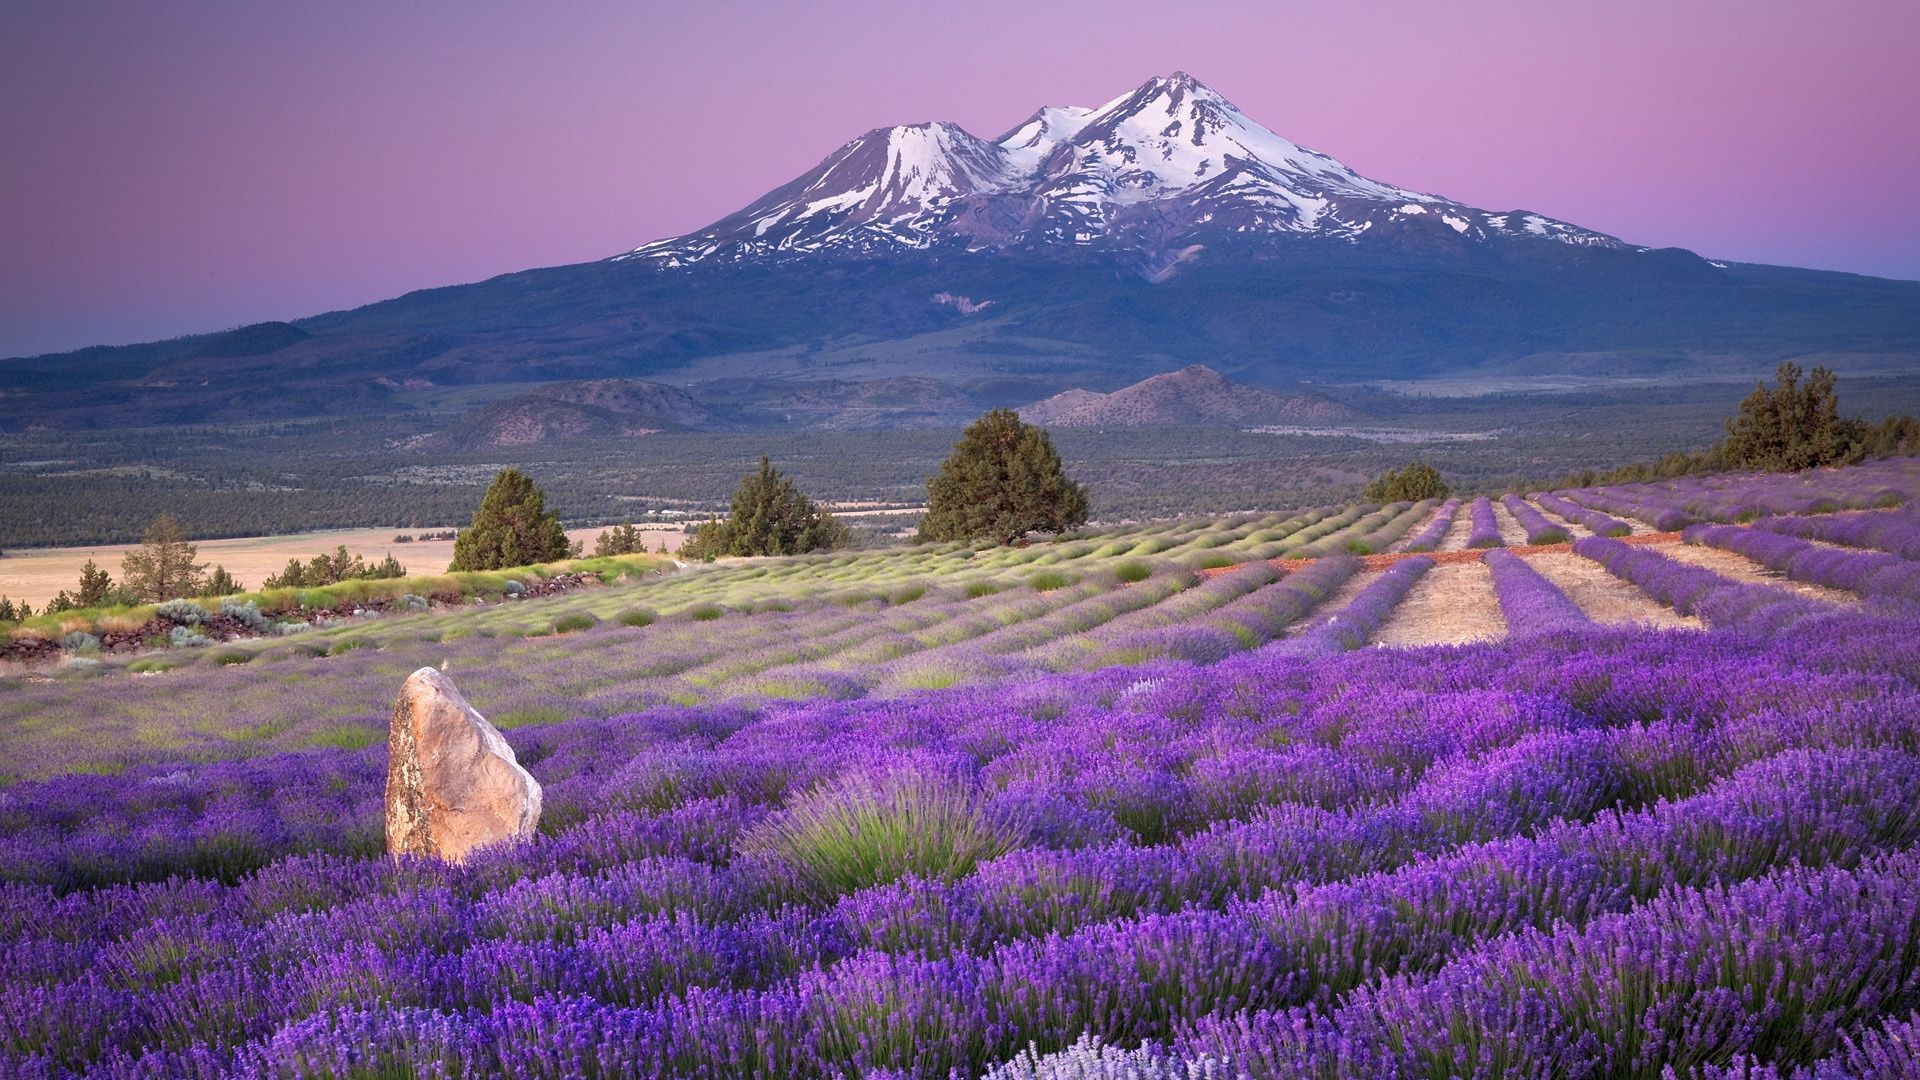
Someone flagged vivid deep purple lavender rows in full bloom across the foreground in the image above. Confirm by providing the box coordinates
[11,599,1920,1076]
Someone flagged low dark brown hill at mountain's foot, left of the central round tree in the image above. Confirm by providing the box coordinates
[430,379,718,450]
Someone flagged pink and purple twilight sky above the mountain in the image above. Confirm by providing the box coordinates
[0,0,1920,356]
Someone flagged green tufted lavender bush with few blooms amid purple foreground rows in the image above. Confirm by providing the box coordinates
[743,769,1027,899]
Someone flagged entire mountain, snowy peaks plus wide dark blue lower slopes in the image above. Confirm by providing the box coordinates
[0,75,1920,430]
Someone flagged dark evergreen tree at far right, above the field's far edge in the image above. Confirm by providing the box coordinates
[1718,363,1866,473]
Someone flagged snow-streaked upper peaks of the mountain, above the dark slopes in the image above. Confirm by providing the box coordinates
[618,71,1624,273]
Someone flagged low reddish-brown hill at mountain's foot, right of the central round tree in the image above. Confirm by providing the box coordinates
[1020,363,1352,427]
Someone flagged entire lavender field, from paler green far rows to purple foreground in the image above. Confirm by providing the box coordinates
[0,459,1920,1080]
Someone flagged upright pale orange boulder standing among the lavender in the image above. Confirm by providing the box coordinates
[386,667,540,863]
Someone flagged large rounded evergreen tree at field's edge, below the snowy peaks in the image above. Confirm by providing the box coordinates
[920,409,1087,544]
